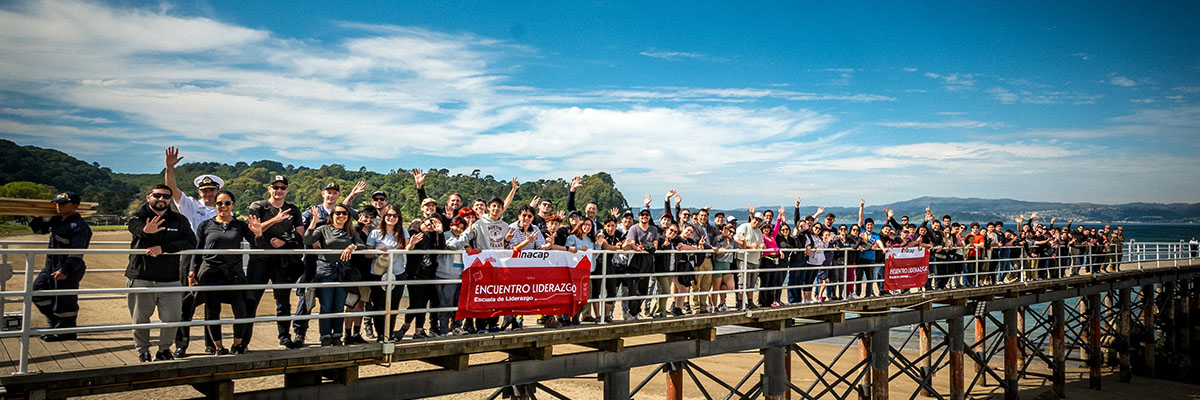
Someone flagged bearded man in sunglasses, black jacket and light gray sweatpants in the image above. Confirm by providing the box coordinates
[125,184,196,362]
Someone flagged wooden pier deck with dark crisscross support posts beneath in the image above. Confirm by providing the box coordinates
[0,259,1200,400]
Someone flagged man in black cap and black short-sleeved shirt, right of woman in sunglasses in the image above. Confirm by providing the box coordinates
[242,175,304,347]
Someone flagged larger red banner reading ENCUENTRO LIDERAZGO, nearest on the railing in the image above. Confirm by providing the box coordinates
[455,250,592,320]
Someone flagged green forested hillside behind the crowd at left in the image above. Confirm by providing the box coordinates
[0,141,628,220]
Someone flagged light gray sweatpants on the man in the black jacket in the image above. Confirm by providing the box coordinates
[126,279,184,353]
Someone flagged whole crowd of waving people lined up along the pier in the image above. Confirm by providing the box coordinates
[31,148,1124,362]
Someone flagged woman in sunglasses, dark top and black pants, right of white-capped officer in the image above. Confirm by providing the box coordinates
[187,190,264,356]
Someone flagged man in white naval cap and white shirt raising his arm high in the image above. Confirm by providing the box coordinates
[162,147,224,358]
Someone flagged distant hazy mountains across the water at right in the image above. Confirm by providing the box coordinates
[686,197,1200,225]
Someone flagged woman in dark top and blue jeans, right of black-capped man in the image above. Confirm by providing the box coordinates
[304,204,366,346]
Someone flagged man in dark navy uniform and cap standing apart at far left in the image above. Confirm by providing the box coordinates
[29,192,91,341]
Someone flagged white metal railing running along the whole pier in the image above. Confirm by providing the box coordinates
[0,240,1189,374]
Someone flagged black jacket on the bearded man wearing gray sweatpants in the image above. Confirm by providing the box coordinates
[125,204,196,282]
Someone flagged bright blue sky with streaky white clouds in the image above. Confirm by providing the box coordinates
[0,0,1200,207]
